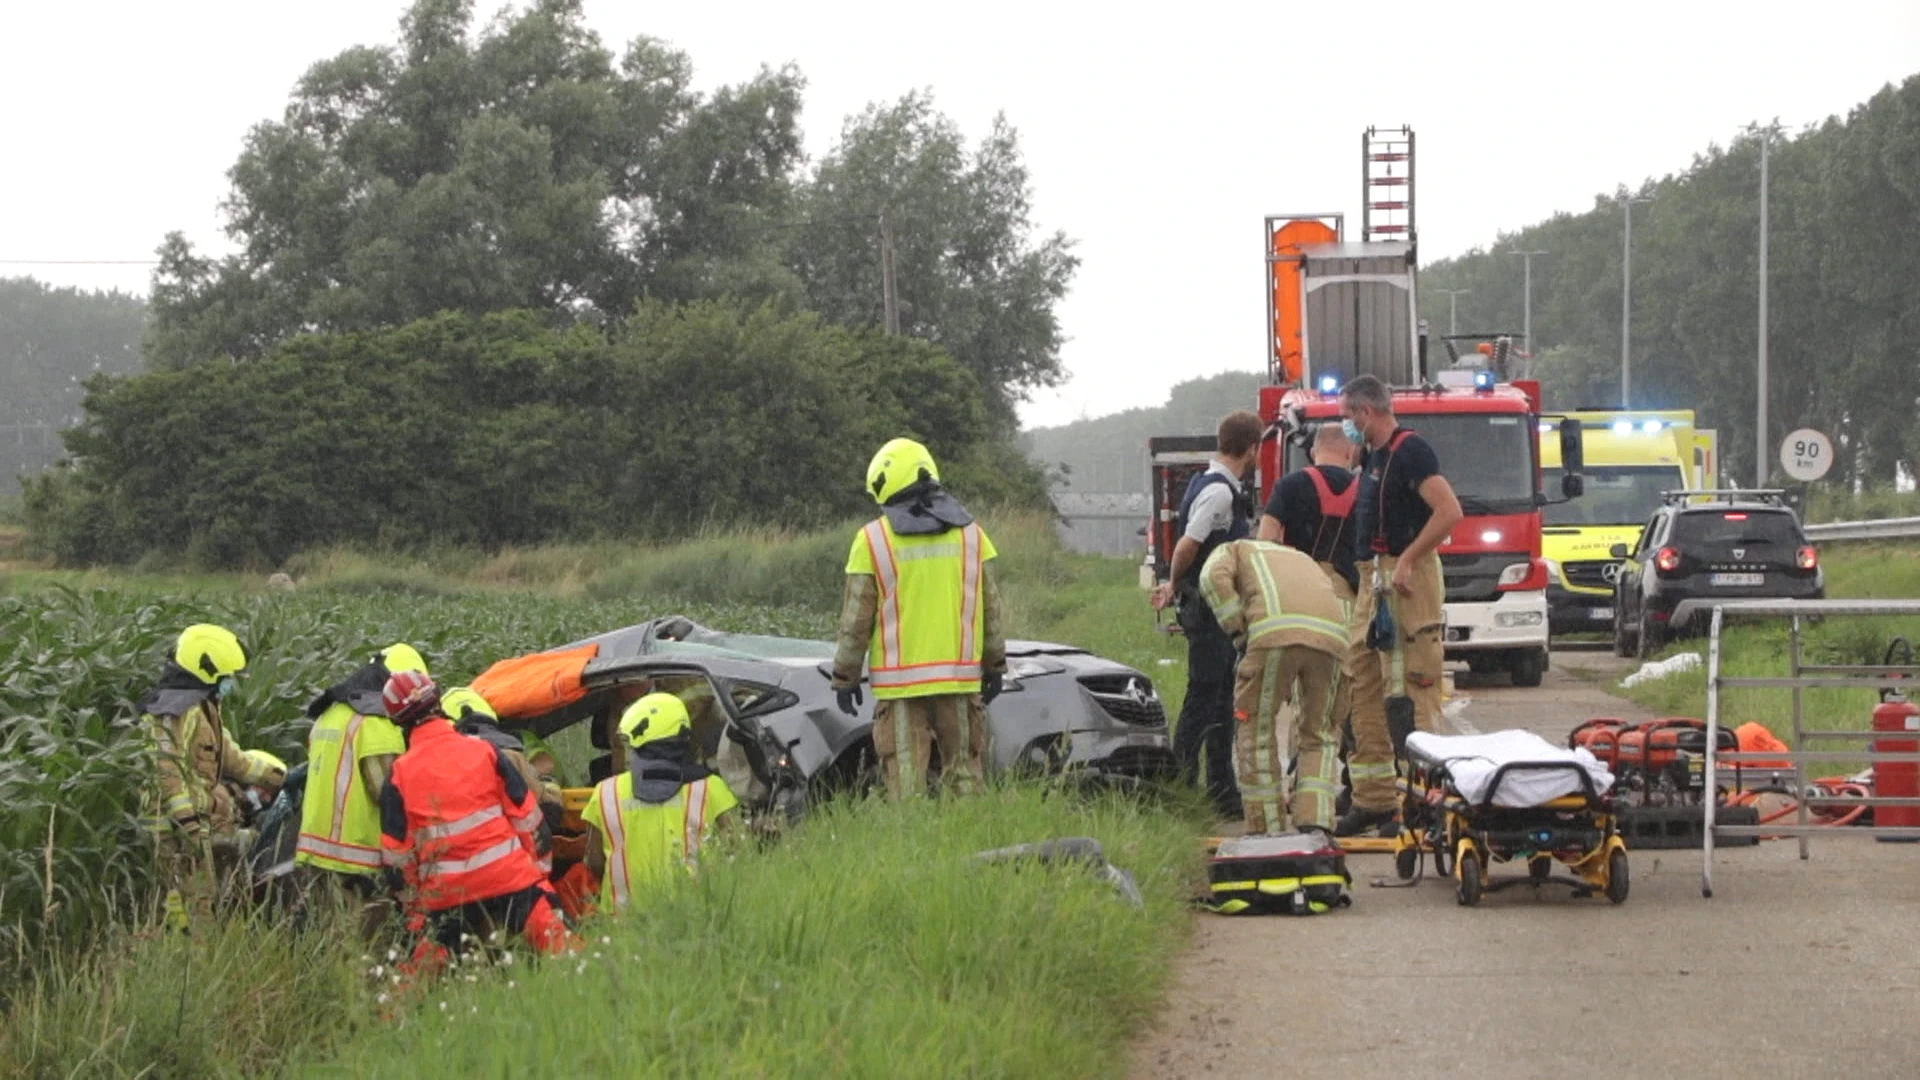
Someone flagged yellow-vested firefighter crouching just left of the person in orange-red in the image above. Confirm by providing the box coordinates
[294,642,426,936]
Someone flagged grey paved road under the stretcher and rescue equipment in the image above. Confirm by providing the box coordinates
[1133,650,1920,1078]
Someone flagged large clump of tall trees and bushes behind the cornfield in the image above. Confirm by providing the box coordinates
[15,0,1077,553]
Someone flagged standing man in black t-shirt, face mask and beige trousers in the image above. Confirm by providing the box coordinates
[1334,375,1461,836]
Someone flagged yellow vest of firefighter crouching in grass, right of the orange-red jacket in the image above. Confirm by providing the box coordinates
[580,773,739,909]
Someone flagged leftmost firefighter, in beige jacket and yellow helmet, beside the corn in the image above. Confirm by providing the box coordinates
[140,623,286,928]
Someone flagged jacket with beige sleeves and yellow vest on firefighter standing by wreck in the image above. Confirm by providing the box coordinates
[833,517,1006,700]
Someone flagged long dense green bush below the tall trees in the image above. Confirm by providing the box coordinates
[25,304,1043,567]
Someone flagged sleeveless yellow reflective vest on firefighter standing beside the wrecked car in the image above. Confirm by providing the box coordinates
[847,517,996,700]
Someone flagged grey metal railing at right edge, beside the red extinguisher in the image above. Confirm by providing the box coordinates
[1699,600,1920,897]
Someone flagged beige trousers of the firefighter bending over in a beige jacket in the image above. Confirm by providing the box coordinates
[1233,646,1340,836]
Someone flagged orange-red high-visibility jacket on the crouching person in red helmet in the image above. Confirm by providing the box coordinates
[380,719,545,911]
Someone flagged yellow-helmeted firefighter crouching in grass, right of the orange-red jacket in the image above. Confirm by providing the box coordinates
[580,694,739,911]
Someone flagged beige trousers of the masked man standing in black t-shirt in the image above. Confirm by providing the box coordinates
[1346,552,1446,811]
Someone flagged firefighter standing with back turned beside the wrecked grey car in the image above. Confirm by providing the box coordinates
[833,438,1006,798]
